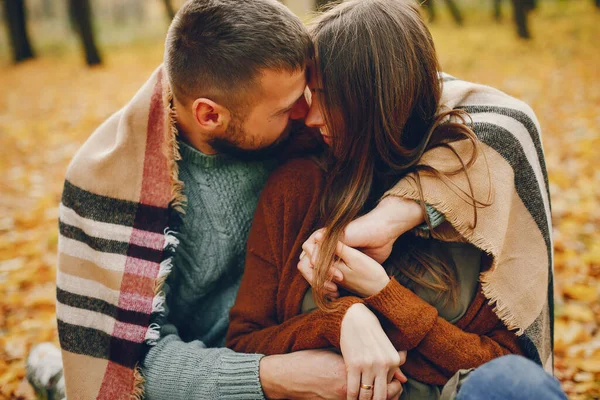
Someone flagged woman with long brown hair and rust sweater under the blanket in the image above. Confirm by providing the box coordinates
[227,0,551,399]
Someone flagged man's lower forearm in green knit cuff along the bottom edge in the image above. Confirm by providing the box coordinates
[142,325,354,400]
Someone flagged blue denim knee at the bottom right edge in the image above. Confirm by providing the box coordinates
[456,355,567,400]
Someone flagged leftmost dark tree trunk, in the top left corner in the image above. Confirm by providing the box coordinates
[4,0,35,63]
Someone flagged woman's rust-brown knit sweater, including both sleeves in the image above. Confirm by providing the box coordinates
[227,159,521,385]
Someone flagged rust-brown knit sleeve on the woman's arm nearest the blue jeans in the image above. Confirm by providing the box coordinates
[365,278,522,385]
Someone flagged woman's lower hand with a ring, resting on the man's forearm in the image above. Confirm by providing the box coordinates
[340,304,407,400]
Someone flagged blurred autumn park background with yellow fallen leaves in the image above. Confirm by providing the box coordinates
[0,0,600,399]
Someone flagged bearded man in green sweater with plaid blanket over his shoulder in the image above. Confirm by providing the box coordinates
[57,0,414,399]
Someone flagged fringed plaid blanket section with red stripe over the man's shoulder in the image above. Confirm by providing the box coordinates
[56,67,184,399]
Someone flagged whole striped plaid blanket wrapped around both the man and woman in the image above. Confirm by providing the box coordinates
[56,67,552,400]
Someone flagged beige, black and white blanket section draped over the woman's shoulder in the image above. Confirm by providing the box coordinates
[387,74,554,373]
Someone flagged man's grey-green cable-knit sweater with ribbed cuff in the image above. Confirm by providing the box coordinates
[142,142,275,400]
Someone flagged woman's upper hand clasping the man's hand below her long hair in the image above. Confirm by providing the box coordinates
[298,241,390,298]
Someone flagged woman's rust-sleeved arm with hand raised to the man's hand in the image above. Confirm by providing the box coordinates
[324,243,521,384]
